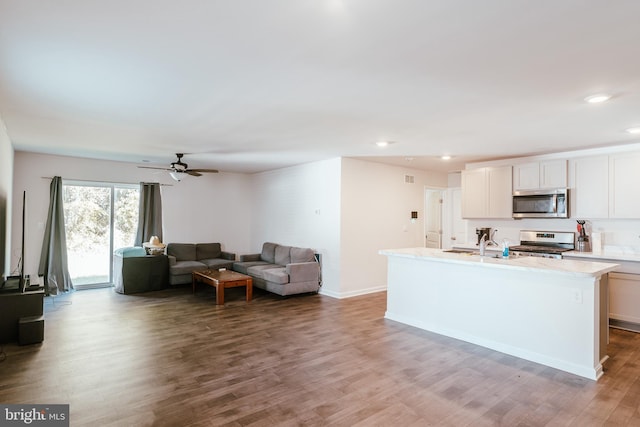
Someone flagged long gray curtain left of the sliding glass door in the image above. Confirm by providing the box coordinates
[38,176,73,295]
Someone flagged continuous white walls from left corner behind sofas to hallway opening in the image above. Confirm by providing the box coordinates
[11,152,447,297]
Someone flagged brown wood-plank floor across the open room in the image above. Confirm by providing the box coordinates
[0,286,640,426]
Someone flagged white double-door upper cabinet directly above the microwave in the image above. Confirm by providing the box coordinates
[513,160,567,191]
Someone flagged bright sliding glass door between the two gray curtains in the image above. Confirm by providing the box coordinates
[63,181,140,289]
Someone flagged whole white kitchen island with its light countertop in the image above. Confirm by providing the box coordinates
[380,248,618,380]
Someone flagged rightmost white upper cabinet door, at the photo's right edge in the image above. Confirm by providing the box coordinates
[609,153,640,219]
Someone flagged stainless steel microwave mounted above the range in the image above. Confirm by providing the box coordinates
[513,188,569,218]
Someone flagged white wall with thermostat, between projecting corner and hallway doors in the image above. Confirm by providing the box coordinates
[339,158,447,297]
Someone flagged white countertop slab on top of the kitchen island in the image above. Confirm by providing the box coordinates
[379,247,620,277]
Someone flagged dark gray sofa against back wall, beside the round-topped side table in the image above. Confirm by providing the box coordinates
[167,243,236,285]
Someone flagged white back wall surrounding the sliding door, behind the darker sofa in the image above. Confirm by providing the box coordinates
[11,151,251,277]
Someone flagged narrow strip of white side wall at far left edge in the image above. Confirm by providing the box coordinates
[0,117,13,276]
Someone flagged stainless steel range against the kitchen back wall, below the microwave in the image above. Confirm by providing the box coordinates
[509,230,576,259]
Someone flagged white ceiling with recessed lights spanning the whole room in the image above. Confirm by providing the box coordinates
[0,0,640,172]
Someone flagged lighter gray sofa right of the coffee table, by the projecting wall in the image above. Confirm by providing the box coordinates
[233,242,321,296]
